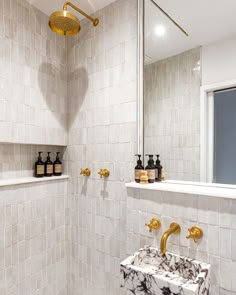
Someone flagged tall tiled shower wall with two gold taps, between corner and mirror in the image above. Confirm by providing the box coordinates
[66,0,137,295]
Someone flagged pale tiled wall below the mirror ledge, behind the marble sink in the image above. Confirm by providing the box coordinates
[127,189,236,295]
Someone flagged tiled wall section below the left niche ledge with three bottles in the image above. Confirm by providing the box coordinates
[0,180,67,295]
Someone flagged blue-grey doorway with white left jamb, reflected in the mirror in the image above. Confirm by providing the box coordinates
[201,82,236,184]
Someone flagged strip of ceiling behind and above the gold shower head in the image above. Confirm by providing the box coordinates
[28,0,114,18]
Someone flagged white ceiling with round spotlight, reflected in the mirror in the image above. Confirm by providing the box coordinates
[145,0,236,63]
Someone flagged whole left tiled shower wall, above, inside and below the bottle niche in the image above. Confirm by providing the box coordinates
[0,0,67,295]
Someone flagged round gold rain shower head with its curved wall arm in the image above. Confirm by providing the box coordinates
[48,2,99,36]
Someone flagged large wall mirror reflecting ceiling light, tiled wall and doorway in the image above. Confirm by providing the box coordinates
[140,0,236,184]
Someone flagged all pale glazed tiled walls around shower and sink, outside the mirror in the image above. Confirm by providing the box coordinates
[0,0,236,295]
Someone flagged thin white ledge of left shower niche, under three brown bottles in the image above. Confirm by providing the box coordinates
[0,175,69,187]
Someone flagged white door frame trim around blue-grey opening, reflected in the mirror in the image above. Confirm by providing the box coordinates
[200,79,236,182]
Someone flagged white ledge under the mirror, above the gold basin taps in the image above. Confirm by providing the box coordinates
[126,181,236,199]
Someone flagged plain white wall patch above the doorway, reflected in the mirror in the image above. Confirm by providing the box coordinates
[202,38,236,85]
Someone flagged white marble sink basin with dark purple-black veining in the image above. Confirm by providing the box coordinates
[120,247,211,295]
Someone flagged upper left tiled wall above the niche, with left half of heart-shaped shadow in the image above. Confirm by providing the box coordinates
[0,0,67,145]
